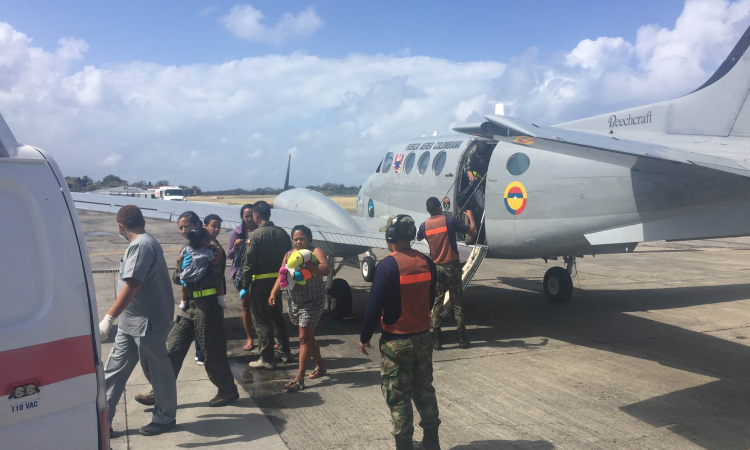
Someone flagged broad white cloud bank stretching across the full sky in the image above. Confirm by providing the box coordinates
[0,0,750,189]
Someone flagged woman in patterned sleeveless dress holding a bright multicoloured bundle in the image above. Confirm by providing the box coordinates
[268,225,330,392]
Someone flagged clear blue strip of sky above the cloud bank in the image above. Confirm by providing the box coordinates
[0,0,684,65]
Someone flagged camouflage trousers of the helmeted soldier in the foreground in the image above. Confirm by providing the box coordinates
[380,331,440,436]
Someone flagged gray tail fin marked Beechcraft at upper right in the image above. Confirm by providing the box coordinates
[557,27,750,136]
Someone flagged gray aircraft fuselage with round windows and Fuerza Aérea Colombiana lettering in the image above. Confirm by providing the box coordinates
[357,135,750,259]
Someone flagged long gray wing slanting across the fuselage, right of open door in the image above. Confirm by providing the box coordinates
[464,114,750,177]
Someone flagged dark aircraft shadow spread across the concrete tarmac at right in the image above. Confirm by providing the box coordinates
[468,277,750,450]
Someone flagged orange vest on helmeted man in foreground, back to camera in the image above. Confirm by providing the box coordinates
[380,249,432,334]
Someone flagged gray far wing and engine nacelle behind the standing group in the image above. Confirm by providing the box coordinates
[71,189,429,256]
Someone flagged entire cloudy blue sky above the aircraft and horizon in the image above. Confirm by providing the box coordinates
[0,0,750,189]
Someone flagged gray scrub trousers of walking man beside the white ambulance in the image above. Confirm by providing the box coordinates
[104,329,177,425]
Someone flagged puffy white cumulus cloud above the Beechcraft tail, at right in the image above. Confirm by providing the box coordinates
[492,0,750,124]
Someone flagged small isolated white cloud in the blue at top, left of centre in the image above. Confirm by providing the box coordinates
[220,5,323,44]
